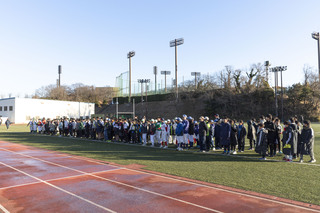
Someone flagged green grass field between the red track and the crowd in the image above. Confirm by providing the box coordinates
[0,124,320,205]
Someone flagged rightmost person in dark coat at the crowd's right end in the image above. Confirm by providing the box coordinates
[299,121,316,163]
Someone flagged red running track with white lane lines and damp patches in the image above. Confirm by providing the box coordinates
[0,142,320,213]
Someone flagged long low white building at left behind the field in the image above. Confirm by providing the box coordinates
[0,98,95,124]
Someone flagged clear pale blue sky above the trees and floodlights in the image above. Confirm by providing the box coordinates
[0,0,320,97]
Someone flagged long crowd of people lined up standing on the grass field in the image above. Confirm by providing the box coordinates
[28,114,316,163]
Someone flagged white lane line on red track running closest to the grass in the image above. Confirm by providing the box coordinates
[43,149,320,212]
